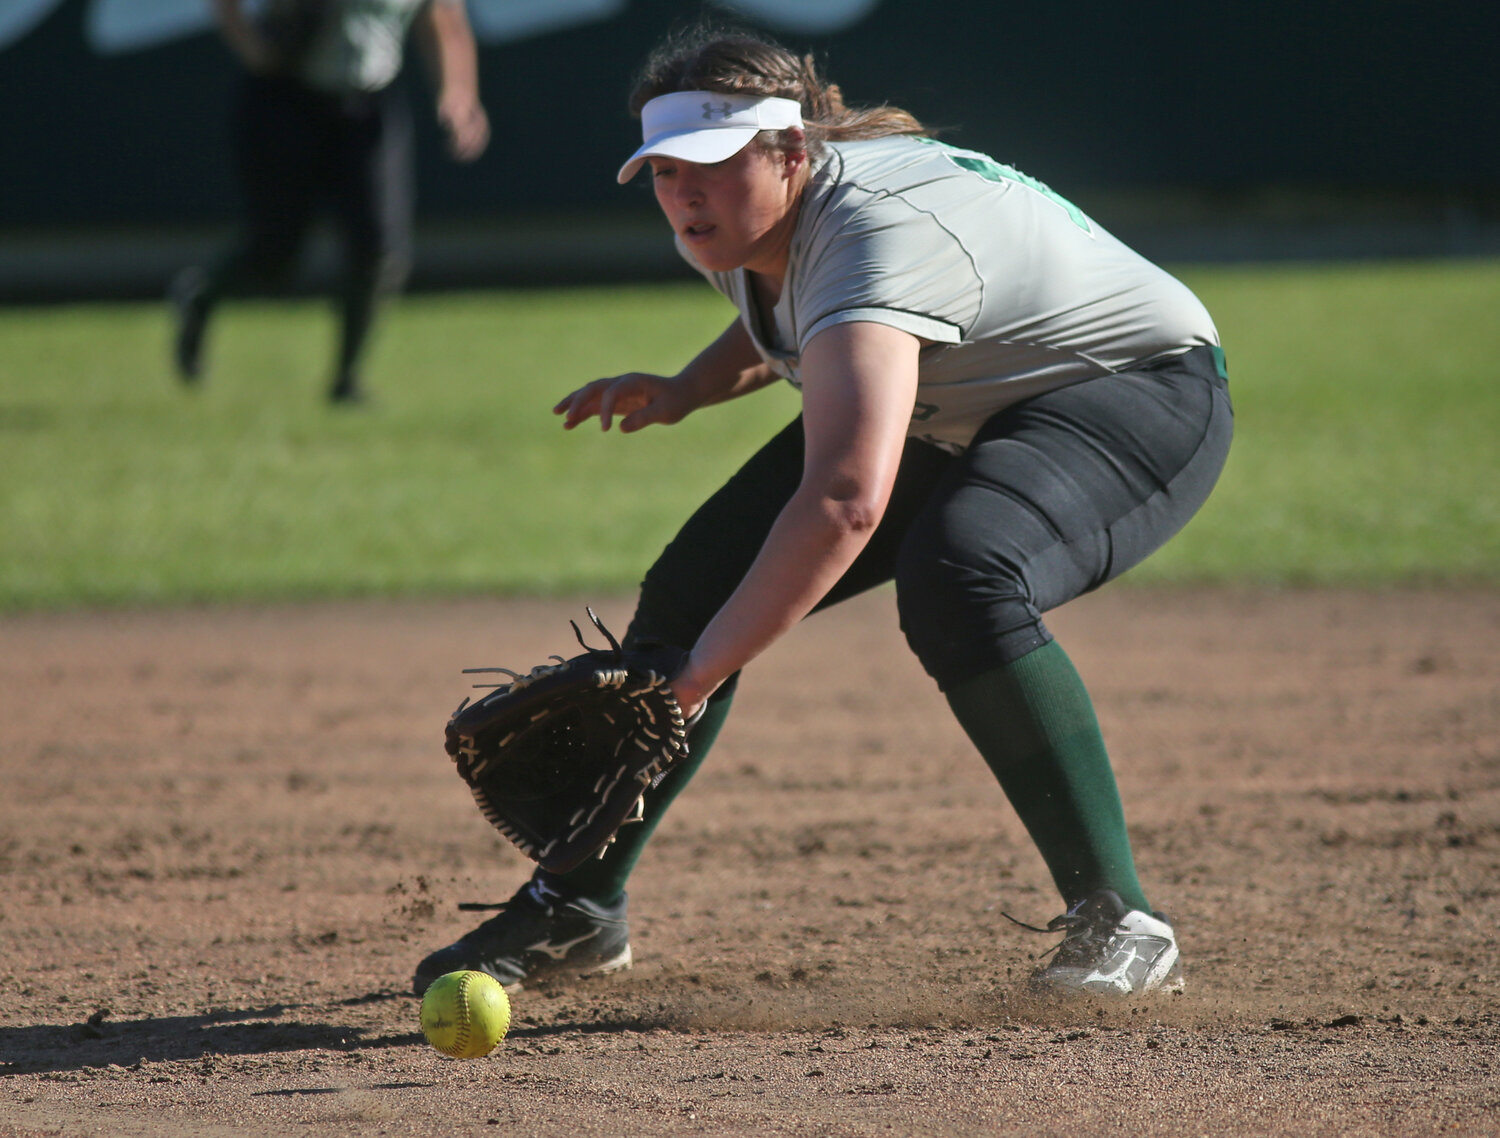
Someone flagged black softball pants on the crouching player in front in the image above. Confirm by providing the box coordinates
[630,348,1233,691]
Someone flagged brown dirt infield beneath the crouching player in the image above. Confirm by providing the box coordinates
[0,588,1500,1137]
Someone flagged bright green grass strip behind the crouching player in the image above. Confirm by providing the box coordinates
[0,261,1500,612]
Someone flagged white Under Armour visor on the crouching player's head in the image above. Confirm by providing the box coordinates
[615,91,803,184]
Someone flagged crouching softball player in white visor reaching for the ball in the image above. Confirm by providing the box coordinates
[416,24,1232,994]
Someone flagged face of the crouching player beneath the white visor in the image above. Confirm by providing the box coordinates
[651,144,806,279]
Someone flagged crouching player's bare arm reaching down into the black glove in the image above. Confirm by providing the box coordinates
[672,324,921,714]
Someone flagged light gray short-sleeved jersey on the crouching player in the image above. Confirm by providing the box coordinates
[680,136,1218,450]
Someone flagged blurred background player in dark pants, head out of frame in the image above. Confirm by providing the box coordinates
[171,0,489,403]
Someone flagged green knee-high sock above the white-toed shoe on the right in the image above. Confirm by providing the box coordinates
[948,642,1151,913]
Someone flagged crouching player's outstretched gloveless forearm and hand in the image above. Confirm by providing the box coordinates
[552,319,779,433]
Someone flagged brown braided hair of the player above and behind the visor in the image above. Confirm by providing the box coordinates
[630,25,927,157]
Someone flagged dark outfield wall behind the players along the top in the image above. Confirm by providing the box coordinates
[0,0,1500,228]
